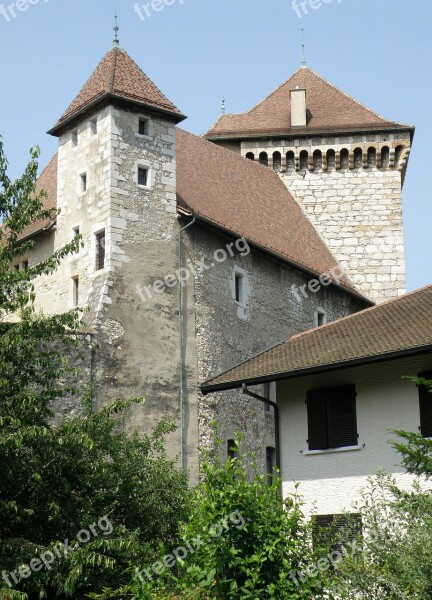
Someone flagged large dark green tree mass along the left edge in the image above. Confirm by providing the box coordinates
[0,140,188,600]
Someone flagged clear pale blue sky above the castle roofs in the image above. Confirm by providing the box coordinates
[0,0,432,290]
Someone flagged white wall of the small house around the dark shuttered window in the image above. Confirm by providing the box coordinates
[276,354,432,514]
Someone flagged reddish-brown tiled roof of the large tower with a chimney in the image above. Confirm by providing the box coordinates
[204,67,413,139]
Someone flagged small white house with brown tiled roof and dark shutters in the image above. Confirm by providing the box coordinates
[202,285,432,516]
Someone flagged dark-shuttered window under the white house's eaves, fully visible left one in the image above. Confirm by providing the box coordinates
[306,385,358,450]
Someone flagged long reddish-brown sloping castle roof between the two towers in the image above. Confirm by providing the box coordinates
[177,129,360,296]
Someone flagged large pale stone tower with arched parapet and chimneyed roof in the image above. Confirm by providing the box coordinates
[205,67,414,302]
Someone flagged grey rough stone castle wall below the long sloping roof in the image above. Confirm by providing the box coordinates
[187,224,365,469]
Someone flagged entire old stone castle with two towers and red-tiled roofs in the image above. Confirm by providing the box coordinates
[15,41,414,482]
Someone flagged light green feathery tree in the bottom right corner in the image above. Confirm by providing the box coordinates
[337,377,432,600]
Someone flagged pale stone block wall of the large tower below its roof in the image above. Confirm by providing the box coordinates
[241,133,410,302]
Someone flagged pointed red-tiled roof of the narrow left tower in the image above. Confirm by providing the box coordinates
[49,47,185,135]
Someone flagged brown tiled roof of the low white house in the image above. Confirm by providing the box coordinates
[201,285,432,393]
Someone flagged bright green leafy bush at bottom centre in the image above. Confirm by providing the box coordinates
[134,437,320,600]
